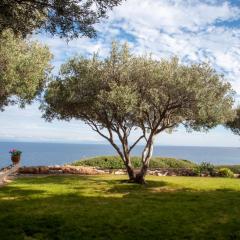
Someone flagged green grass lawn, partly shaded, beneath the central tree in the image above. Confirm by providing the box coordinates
[0,175,240,240]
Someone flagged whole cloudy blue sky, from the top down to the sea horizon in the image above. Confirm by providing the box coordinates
[0,0,240,147]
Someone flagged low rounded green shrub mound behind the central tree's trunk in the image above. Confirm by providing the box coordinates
[72,156,196,169]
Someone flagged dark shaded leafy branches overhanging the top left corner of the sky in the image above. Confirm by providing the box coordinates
[0,0,122,39]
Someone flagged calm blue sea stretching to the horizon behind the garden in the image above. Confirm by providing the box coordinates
[0,142,240,168]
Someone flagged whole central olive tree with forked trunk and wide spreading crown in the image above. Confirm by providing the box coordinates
[42,43,233,183]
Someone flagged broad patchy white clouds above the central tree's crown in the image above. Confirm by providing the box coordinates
[35,0,240,90]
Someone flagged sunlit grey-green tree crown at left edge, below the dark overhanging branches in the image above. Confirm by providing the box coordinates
[0,30,52,110]
